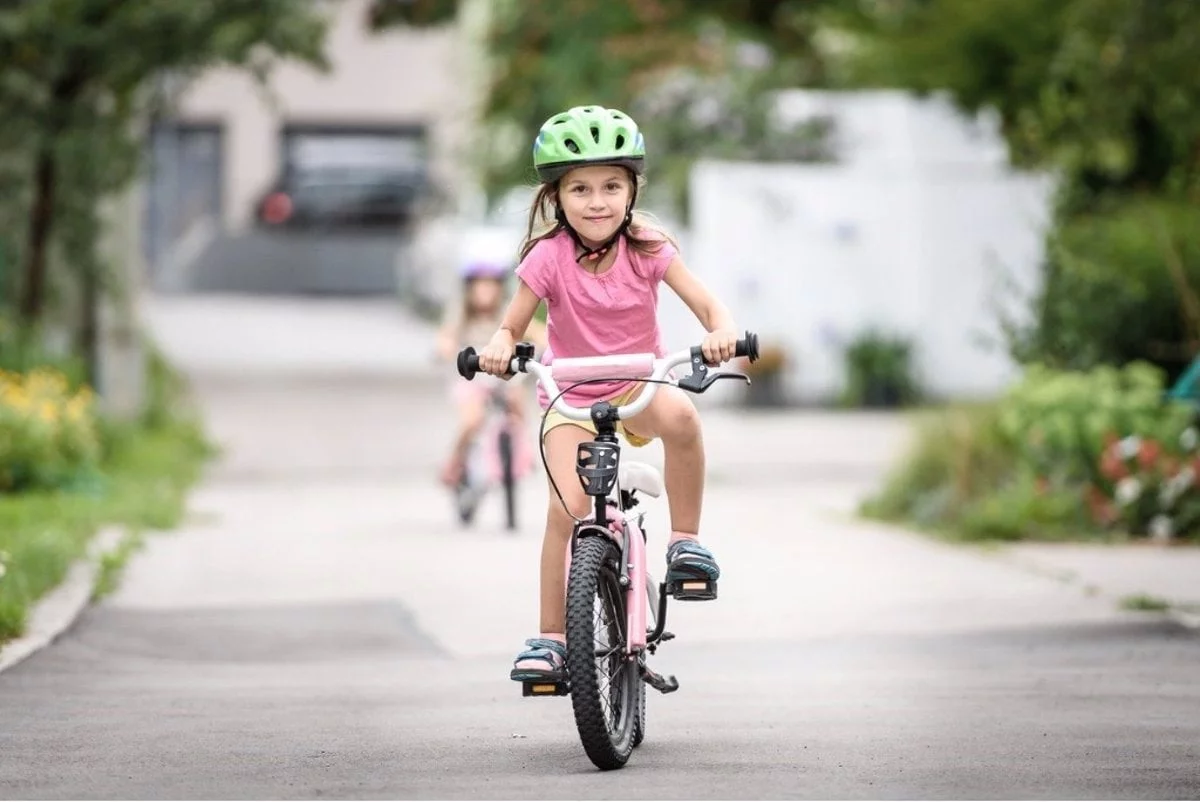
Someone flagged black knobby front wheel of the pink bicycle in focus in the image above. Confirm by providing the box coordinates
[566,534,642,771]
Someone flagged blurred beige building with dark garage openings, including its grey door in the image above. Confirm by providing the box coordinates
[145,0,479,268]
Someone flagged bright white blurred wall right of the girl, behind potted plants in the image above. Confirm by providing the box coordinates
[672,91,1050,401]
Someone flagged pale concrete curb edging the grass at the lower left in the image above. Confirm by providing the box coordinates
[0,527,128,672]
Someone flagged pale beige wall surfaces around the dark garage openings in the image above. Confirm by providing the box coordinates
[176,0,474,229]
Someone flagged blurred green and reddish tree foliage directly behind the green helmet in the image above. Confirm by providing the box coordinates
[373,0,845,204]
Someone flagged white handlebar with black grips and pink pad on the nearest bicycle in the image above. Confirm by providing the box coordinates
[457,331,758,420]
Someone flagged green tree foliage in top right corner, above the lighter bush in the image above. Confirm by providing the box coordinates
[827,0,1200,205]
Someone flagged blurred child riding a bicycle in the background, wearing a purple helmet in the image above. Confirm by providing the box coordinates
[437,261,541,487]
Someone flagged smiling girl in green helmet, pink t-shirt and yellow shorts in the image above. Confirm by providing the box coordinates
[479,106,738,682]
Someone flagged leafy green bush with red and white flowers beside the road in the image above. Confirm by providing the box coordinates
[863,363,1200,540]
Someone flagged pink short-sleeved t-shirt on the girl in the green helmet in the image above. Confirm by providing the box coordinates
[516,232,676,409]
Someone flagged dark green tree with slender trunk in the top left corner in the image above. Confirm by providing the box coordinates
[0,0,326,362]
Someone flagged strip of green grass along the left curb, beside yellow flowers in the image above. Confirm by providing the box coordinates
[0,354,215,645]
